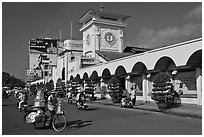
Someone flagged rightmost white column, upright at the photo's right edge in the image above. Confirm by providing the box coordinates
[196,67,202,107]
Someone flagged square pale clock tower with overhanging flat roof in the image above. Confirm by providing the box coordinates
[78,9,130,58]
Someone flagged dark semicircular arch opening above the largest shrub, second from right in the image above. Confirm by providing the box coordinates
[154,56,176,71]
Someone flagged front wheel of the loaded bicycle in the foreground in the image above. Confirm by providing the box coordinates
[52,115,67,132]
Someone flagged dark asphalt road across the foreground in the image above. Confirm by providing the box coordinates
[2,97,202,135]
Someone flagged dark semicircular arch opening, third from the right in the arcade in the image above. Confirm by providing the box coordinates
[131,62,147,74]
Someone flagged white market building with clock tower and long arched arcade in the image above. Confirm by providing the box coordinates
[27,9,202,106]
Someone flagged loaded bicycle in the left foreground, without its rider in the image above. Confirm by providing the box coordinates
[24,100,67,132]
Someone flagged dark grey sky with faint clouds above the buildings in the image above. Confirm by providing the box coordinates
[2,1,202,79]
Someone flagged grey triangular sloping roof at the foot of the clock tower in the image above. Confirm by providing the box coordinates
[96,50,132,61]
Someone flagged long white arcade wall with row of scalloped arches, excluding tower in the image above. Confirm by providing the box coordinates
[68,39,202,105]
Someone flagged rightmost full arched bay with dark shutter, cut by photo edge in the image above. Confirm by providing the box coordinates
[175,50,202,105]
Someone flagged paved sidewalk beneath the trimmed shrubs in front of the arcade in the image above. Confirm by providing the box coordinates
[92,99,202,119]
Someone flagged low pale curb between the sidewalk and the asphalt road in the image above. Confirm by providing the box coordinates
[91,101,202,119]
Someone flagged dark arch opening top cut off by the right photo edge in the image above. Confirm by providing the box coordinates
[186,50,202,68]
